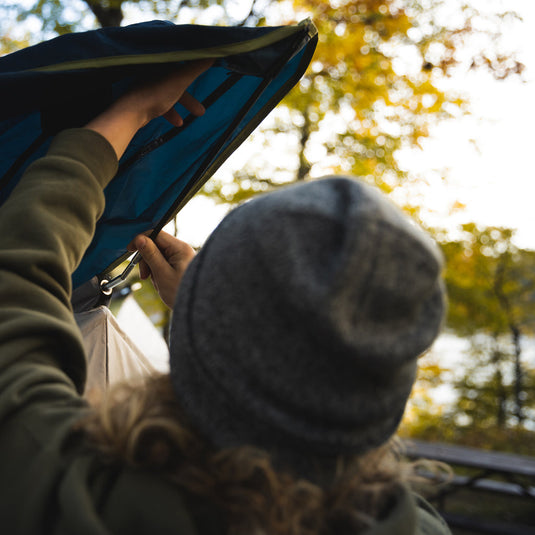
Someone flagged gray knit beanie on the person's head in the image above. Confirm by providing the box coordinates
[171,177,445,474]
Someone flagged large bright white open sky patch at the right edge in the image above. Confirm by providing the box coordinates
[403,0,535,249]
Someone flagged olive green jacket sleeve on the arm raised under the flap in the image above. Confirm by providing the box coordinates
[0,128,117,402]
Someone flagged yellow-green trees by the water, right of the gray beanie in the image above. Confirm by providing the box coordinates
[406,223,535,455]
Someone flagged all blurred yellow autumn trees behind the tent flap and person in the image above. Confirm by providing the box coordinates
[0,0,535,448]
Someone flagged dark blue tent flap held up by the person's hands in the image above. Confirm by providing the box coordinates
[0,20,317,288]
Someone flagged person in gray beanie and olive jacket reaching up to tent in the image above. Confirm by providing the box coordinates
[0,56,449,535]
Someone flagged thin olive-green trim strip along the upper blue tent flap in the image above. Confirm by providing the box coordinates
[28,19,317,72]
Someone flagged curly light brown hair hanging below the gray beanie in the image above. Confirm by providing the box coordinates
[79,375,442,535]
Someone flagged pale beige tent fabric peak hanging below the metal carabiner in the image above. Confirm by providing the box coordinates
[74,306,156,395]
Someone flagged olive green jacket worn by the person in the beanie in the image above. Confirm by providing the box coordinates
[0,129,448,535]
